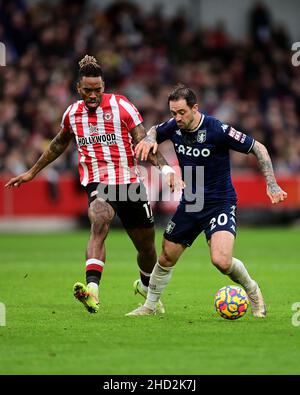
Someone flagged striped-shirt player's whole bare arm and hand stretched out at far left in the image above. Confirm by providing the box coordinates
[5,129,72,188]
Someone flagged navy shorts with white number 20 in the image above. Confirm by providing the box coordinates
[164,201,236,247]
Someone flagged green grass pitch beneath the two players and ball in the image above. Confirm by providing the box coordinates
[0,228,300,375]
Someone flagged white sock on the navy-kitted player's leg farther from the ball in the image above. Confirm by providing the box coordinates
[144,262,174,310]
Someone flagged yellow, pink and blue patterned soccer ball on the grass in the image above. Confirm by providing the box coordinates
[215,285,249,320]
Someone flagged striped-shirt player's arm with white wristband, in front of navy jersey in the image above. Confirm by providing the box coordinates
[130,124,185,192]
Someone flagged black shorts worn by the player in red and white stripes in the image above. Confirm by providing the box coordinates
[85,182,154,229]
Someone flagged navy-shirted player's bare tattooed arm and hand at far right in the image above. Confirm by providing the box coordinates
[251,141,287,204]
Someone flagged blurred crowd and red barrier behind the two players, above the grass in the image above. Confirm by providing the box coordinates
[0,0,300,231]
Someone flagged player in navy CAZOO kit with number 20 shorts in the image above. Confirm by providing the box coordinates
[127,85,287,318]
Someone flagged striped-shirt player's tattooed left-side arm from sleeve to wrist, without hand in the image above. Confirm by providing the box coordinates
[31,130,72,175]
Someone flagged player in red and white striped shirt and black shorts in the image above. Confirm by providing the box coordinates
[6,55,183,313]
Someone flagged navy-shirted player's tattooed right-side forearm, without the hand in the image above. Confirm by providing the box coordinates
[251,141,280,193]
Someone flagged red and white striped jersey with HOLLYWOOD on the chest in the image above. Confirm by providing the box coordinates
[61,93,143,186]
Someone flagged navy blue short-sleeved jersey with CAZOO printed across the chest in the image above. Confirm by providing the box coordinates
[156,114,254,206]
